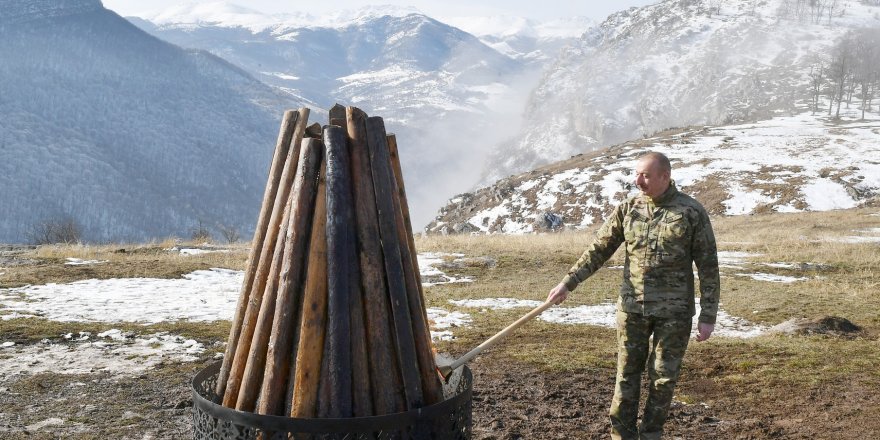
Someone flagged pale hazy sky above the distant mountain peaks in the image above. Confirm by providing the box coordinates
[103,0,658,20]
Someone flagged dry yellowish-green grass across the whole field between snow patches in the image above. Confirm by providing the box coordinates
[0,209,880,438]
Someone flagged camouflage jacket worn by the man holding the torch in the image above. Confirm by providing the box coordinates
[563,183,720,324]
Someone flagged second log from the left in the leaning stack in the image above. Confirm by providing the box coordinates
[223,108,309,408]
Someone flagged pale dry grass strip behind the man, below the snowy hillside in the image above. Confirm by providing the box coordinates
[416,209,880,329]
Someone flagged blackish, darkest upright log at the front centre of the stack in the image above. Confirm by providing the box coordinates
[322,125,357,418]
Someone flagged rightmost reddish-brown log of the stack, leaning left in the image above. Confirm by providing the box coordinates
[388,135,443,405]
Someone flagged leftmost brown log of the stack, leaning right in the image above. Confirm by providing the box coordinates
[215,110,299,396]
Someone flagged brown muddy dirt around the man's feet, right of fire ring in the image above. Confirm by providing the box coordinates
[473,358,880,440]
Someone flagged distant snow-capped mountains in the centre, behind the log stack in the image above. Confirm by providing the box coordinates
[125,2,543,226]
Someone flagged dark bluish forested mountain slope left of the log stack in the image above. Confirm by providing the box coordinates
[0,0,299,242]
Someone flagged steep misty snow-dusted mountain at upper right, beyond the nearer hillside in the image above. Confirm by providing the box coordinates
[484,0,880,183]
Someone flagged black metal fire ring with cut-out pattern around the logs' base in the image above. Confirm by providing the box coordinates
[192,362,473,440]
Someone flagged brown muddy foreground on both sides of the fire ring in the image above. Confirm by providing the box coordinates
[0,350,880,440]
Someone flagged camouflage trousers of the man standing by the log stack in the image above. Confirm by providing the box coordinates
[610,311,692,440]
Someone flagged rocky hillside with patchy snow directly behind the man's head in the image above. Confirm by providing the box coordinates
[427,106,880,233]
